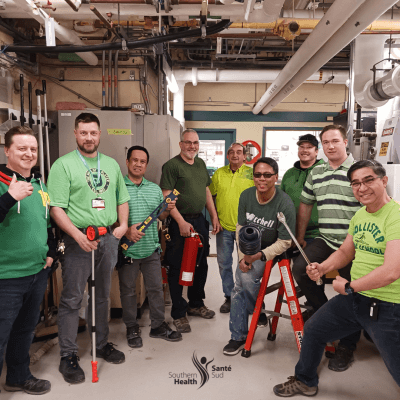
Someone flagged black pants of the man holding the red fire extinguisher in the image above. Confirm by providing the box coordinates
[165,214,210,319]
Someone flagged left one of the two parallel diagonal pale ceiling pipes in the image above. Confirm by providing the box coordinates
[253,0,366,114]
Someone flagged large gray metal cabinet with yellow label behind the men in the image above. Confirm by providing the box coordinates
[58,110,180,184]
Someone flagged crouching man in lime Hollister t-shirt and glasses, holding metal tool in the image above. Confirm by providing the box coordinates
[274,160,400,397]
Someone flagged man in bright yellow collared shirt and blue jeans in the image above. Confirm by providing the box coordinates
[210,143,254,313]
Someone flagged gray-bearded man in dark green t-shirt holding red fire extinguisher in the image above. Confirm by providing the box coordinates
[160,129,221,333]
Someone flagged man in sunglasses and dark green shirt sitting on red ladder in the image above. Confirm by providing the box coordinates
[223,157,296,356]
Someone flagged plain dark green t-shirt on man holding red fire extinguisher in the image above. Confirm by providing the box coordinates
[160,155,211,214]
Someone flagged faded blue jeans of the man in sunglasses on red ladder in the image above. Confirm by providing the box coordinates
[229,260,265,340]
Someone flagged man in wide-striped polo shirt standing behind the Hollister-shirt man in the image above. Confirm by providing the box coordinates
[293,125,361,371]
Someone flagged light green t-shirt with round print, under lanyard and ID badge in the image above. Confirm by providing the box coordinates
[47,150,129,228]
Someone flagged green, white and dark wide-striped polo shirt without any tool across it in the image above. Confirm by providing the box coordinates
[300,154,361,250]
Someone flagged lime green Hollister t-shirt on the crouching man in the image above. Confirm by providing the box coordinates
[349,200,400,303]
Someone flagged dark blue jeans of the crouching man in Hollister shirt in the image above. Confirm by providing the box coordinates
[295,293,400,386]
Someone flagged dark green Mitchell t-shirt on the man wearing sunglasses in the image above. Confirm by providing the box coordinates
[238,187,296,249]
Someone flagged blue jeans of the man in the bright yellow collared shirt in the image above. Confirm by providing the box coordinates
[216,229,236,297]
